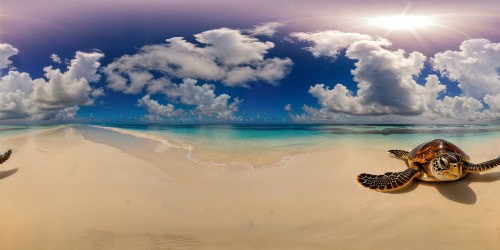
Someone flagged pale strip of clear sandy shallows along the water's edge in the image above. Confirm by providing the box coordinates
[93,125,496,171]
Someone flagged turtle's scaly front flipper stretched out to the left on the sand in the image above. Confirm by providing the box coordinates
[357,168,420,192]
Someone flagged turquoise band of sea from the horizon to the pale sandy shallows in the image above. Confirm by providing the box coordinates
[95,124,500,152]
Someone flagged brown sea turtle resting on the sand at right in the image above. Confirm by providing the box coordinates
[357,139,500,192]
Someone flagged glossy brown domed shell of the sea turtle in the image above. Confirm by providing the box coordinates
[408,139,470,164]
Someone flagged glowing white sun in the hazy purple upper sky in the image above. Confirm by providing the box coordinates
[368,14,435,31]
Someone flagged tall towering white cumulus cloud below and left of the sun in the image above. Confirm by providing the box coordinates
[309,40,430,115]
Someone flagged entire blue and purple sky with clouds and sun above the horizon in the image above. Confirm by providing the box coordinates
[0,0,500,124]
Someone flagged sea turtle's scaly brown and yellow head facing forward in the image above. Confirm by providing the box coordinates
[430,154,462,181]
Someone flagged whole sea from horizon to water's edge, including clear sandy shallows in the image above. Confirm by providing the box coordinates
[83,124,500,170]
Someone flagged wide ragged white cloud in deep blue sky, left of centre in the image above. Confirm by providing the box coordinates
[104,28,293,94]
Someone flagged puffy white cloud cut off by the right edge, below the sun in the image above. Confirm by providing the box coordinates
[431,39,500,100]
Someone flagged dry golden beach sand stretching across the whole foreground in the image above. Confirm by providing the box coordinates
[0,126,500,249]
